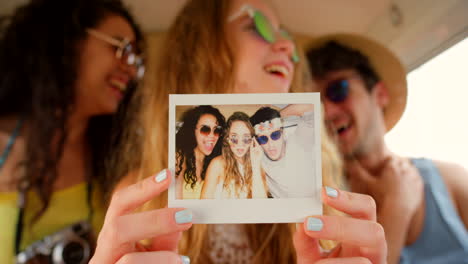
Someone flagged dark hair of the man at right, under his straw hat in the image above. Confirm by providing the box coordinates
[306,41,380,92]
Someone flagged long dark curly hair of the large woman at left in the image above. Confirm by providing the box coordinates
[0,0,143,221]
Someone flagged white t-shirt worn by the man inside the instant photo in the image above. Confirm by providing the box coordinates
[262,112,316,198]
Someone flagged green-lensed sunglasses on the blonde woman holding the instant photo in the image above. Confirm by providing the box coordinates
[228,4,299,63]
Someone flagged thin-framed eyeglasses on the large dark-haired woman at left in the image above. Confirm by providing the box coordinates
[86,29,145,79]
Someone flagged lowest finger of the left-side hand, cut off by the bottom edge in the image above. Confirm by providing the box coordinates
[116,251,190,264]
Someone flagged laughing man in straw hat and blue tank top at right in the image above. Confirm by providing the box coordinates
[307,34,468,264]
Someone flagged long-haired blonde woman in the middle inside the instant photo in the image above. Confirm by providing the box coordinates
[201,112,267,199]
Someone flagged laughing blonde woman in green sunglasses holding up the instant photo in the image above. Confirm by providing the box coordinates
[91,0,387,264]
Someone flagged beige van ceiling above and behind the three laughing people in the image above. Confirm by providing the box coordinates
[0,0,468,71]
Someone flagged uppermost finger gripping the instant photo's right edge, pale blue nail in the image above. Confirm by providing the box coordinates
[322,186,377,221]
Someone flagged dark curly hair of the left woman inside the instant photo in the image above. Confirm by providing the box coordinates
[176,105,226,188]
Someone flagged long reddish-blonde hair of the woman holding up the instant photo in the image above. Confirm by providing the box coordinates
[111,0,342,264]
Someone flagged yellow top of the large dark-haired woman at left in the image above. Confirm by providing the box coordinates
[0,183,105,263]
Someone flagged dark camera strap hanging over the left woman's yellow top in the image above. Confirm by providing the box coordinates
[15,180,93,255]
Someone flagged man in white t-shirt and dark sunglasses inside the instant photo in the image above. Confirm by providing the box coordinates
[250,104,315,198]
